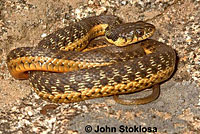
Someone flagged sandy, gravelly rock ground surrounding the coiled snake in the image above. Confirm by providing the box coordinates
[0,0,200,134]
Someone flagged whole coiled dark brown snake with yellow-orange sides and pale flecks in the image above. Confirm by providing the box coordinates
[7,15,176,104]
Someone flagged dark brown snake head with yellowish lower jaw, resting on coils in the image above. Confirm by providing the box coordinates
[105,21,155,46]
